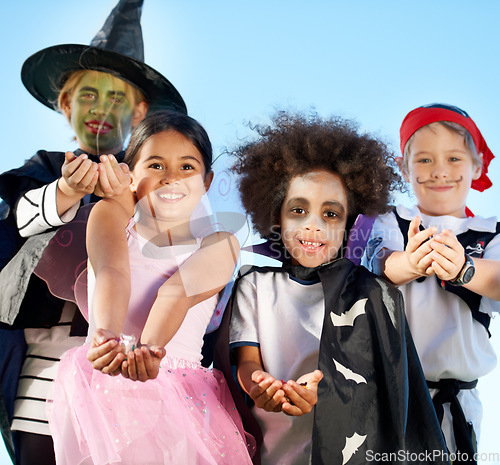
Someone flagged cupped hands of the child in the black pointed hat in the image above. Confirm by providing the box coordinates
[61,152,130,197]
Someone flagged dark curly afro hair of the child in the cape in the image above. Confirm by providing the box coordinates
[232,112,403,238]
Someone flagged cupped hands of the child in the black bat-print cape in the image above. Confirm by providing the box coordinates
[249,370,323,416]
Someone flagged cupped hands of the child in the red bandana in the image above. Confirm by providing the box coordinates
[405,216,465,281]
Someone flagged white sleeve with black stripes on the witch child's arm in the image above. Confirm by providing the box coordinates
[15,180,80,237]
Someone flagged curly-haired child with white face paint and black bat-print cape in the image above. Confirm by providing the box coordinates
[216,113,452,465]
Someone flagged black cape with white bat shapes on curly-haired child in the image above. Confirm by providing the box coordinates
[214,259,449,465]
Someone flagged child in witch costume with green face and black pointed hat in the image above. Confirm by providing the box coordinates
[0,0,186,463]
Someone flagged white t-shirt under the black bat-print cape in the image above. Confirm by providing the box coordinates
[230,271,325,465]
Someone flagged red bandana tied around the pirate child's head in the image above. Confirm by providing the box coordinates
[399,104,494,192]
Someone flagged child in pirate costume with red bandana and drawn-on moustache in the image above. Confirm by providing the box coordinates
[363,104,500,463]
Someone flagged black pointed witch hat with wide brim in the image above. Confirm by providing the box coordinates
[21,0,187,113]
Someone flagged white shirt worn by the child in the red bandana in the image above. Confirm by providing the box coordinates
[361,205,500,447]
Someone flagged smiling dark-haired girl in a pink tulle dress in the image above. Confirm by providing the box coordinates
[48,111,252,465]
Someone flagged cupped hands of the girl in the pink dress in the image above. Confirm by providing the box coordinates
[87,329,165,382]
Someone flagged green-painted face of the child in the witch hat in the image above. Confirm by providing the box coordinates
[70,71,134,155]
